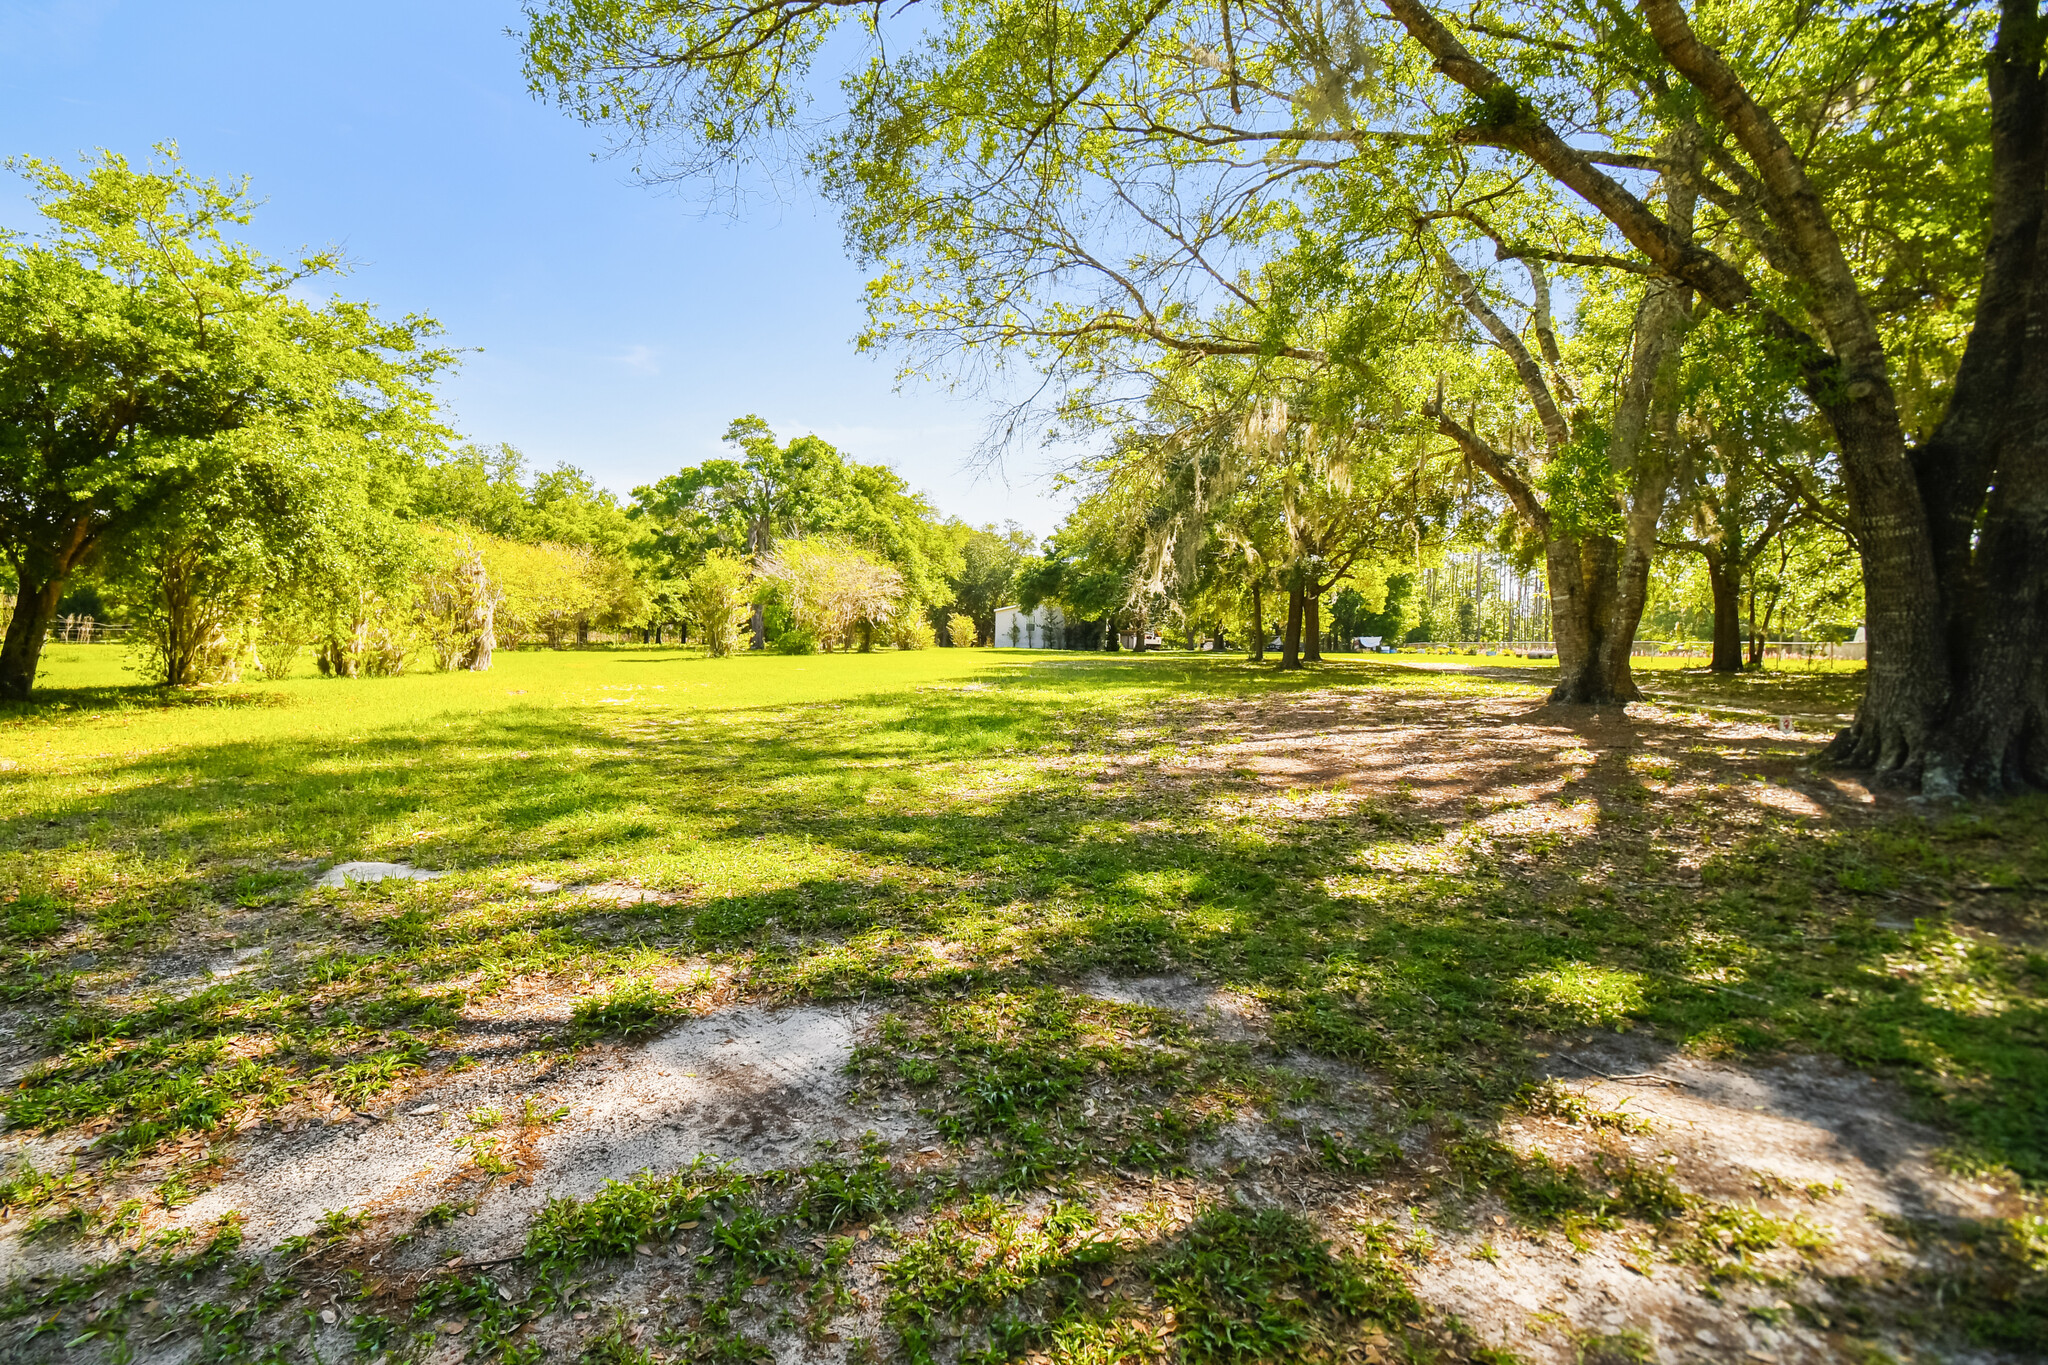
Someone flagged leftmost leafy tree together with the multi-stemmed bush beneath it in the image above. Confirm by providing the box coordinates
[0,149,453,698]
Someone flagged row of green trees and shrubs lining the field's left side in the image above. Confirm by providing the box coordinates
[0,149,1034,700]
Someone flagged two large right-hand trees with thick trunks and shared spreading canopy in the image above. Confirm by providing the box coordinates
[526,0,2048,792]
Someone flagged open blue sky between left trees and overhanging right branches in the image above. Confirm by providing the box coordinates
[0,0,1061,534]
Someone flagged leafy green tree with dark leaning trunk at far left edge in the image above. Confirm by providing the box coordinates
[0,153,451,700]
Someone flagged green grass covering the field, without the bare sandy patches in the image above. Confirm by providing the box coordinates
[0,647,2048,1359]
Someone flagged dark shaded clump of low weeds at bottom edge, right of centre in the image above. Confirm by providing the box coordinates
[1151,1207,1421,1365]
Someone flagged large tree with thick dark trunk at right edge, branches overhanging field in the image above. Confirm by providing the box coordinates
[528,0,2048,794]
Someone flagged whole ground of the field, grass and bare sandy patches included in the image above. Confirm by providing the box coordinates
[0,647,2048,1365]
